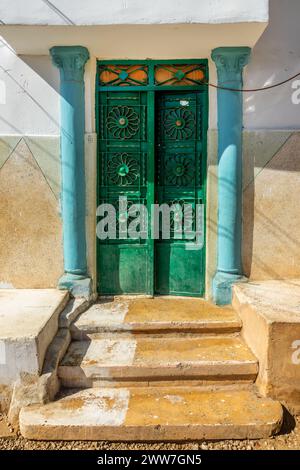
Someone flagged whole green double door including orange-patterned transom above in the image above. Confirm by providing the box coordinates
[96,60,208,296]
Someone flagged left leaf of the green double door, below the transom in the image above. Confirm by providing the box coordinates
[97,91,153,294]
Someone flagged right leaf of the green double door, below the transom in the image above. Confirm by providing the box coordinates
[155,91,205,296]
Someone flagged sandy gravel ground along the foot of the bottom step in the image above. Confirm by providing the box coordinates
[0,415,300,450]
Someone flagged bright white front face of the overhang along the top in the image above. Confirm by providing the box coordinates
[0,0,268,25]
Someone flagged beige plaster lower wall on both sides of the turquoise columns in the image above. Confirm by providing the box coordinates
[0,130,300,292]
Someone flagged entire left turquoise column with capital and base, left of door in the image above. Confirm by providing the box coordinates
[50,46,90,296]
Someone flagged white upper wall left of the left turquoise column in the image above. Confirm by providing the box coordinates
[0,38,60,135]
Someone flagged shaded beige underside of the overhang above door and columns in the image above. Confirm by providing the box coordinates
[0,22,267,56]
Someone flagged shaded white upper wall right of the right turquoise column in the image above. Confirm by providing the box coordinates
[244,0,300,129]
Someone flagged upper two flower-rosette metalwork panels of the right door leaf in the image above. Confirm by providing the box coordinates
[156,92,204,231]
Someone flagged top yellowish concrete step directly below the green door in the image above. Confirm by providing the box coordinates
[71,297,241,340]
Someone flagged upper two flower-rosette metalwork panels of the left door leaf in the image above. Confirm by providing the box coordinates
[99,92,148,201]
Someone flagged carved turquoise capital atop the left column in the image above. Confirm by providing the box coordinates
[50,46,90,82]
